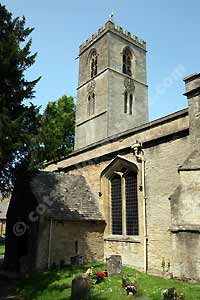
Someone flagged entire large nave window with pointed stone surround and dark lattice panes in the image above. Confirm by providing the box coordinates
[101,156,140,239]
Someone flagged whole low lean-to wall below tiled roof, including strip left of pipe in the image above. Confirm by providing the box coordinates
[37,220,105,269]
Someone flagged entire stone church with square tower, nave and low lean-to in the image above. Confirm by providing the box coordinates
[5,21,200,279]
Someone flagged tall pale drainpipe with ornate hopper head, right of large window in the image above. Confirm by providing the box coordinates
[131,141,148,273]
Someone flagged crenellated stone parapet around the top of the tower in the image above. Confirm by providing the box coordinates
[79,21,146,53]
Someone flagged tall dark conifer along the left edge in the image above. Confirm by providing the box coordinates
[0,4,40,194]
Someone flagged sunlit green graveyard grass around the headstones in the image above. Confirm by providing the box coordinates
[17,263,200,300]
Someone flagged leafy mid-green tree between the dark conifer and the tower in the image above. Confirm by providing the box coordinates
[36,95,75,161]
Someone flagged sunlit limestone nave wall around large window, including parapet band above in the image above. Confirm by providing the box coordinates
[47,112,191,273]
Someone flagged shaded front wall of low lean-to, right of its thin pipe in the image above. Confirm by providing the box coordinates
[51,221,104,264]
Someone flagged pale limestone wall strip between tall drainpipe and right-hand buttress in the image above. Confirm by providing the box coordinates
[145,137,191,272]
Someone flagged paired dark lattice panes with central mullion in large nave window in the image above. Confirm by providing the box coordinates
[110,170,139,236]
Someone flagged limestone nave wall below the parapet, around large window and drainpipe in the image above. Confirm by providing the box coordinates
[67,137,190,273]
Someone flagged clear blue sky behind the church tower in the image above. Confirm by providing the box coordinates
[1,0,200,120]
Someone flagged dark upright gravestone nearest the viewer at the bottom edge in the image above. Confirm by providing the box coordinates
[71,276,92,300]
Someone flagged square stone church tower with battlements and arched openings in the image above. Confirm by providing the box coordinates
[75,21,148,150]
